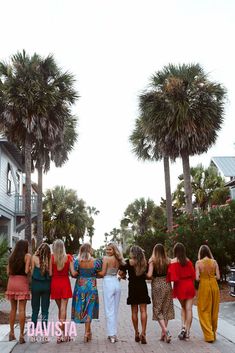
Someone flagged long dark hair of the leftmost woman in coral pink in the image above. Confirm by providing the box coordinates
[9,239,29,275]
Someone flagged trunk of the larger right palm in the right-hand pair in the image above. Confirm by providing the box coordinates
[181,151,193,214]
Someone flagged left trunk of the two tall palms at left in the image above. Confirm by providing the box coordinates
[25,134,32,249]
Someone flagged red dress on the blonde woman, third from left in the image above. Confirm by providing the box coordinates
[51,254,73,299]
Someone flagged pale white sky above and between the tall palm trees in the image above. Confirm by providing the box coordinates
[0,0,235,247]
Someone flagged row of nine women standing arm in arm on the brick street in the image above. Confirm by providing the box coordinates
[6,239,219,344]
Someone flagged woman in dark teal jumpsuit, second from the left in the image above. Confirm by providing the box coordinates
[31,243,51,341]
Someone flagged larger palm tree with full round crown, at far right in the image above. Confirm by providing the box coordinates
[139,64,225,213]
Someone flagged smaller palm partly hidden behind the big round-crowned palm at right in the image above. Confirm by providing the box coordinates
[130,118,173,232]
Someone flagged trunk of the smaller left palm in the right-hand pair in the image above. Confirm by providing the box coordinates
[163,157,173,232]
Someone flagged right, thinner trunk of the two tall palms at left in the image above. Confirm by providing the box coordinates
[36,157,43,248]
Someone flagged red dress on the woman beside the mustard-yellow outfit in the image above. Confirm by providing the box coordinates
[166,260,196,299]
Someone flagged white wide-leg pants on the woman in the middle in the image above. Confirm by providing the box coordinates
[103,275,121,336]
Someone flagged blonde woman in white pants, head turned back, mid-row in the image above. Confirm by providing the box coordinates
[99,243,124,343]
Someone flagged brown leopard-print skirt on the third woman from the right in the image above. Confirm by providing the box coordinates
[152,276,175,320]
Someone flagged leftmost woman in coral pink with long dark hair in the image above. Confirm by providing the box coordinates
[5,240,31,343]
